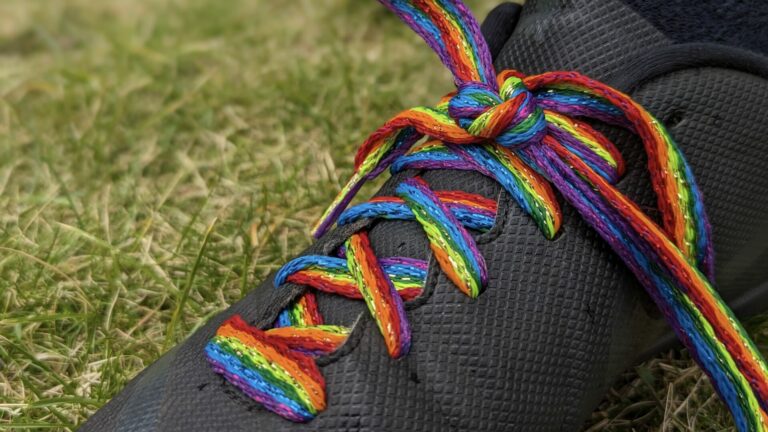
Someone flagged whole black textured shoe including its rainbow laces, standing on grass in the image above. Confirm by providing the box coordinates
[81,0,768,432]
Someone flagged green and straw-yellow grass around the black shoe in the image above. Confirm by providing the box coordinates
[0,0,756,431]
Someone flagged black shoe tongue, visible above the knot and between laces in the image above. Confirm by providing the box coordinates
[318,0,671,325]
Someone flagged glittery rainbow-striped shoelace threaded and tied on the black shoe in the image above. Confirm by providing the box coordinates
[205,0,768,431]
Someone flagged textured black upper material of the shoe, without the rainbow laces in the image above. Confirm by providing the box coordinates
[82,0,768,431]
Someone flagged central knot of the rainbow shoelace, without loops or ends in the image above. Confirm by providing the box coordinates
[448,71,547,147]
